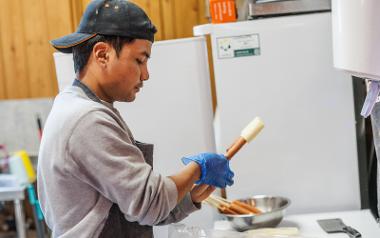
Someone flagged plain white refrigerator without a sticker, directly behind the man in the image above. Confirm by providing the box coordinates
[54,37,215,238]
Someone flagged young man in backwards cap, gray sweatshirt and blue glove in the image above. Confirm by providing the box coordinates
[38,0,233,238]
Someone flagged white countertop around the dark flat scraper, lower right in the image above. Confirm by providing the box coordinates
[279,210,380,238]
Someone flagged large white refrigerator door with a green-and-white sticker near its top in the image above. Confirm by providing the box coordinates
[194,13,360,213]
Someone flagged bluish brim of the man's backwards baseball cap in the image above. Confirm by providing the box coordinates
[50,32,97,53]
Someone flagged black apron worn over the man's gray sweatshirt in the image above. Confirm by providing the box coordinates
[99,141,157,238]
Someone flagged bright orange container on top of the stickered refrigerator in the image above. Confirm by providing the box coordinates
[209,0,236,23]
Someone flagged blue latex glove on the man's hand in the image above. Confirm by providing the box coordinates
[182,153,234,188]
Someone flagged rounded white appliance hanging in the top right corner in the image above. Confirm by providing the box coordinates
[332,0,380,80]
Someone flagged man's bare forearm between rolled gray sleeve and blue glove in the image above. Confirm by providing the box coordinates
[169,162,201,203]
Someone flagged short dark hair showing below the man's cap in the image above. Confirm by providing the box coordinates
[73,35,134,73]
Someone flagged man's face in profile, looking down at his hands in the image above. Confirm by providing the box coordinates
[101,39,152,102]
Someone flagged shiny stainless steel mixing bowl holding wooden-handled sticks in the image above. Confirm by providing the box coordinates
[222,195,290,231]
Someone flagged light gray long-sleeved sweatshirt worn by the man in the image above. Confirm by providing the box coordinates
[37,86,198,237]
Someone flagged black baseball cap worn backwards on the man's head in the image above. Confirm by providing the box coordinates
[50,0,157,53]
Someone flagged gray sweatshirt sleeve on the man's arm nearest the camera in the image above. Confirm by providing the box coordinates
[67,111,178,225]
